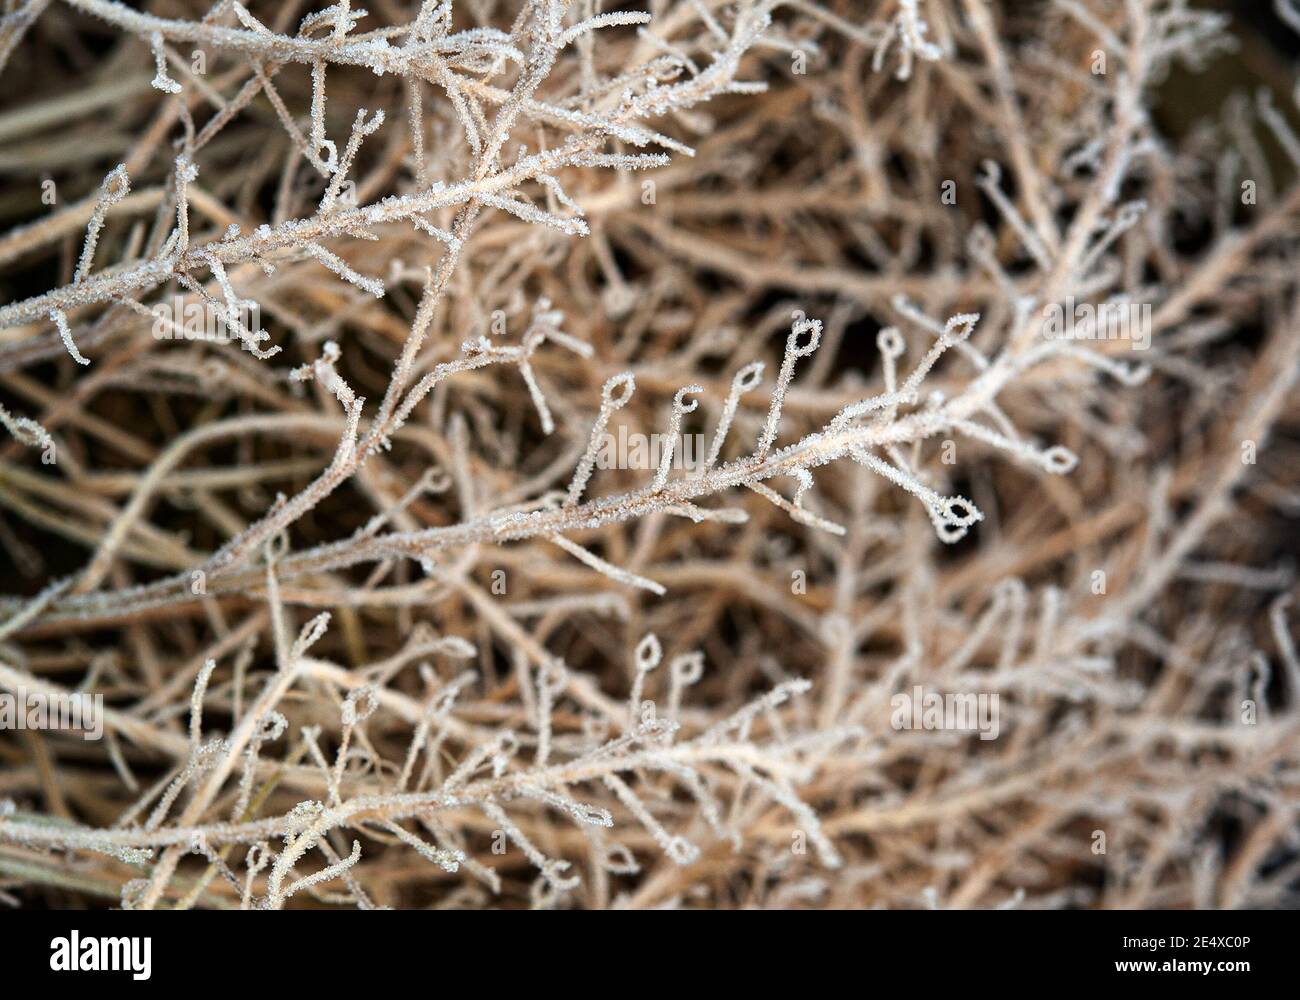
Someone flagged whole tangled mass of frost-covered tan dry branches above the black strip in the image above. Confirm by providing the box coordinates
[0,0,1300,909]
